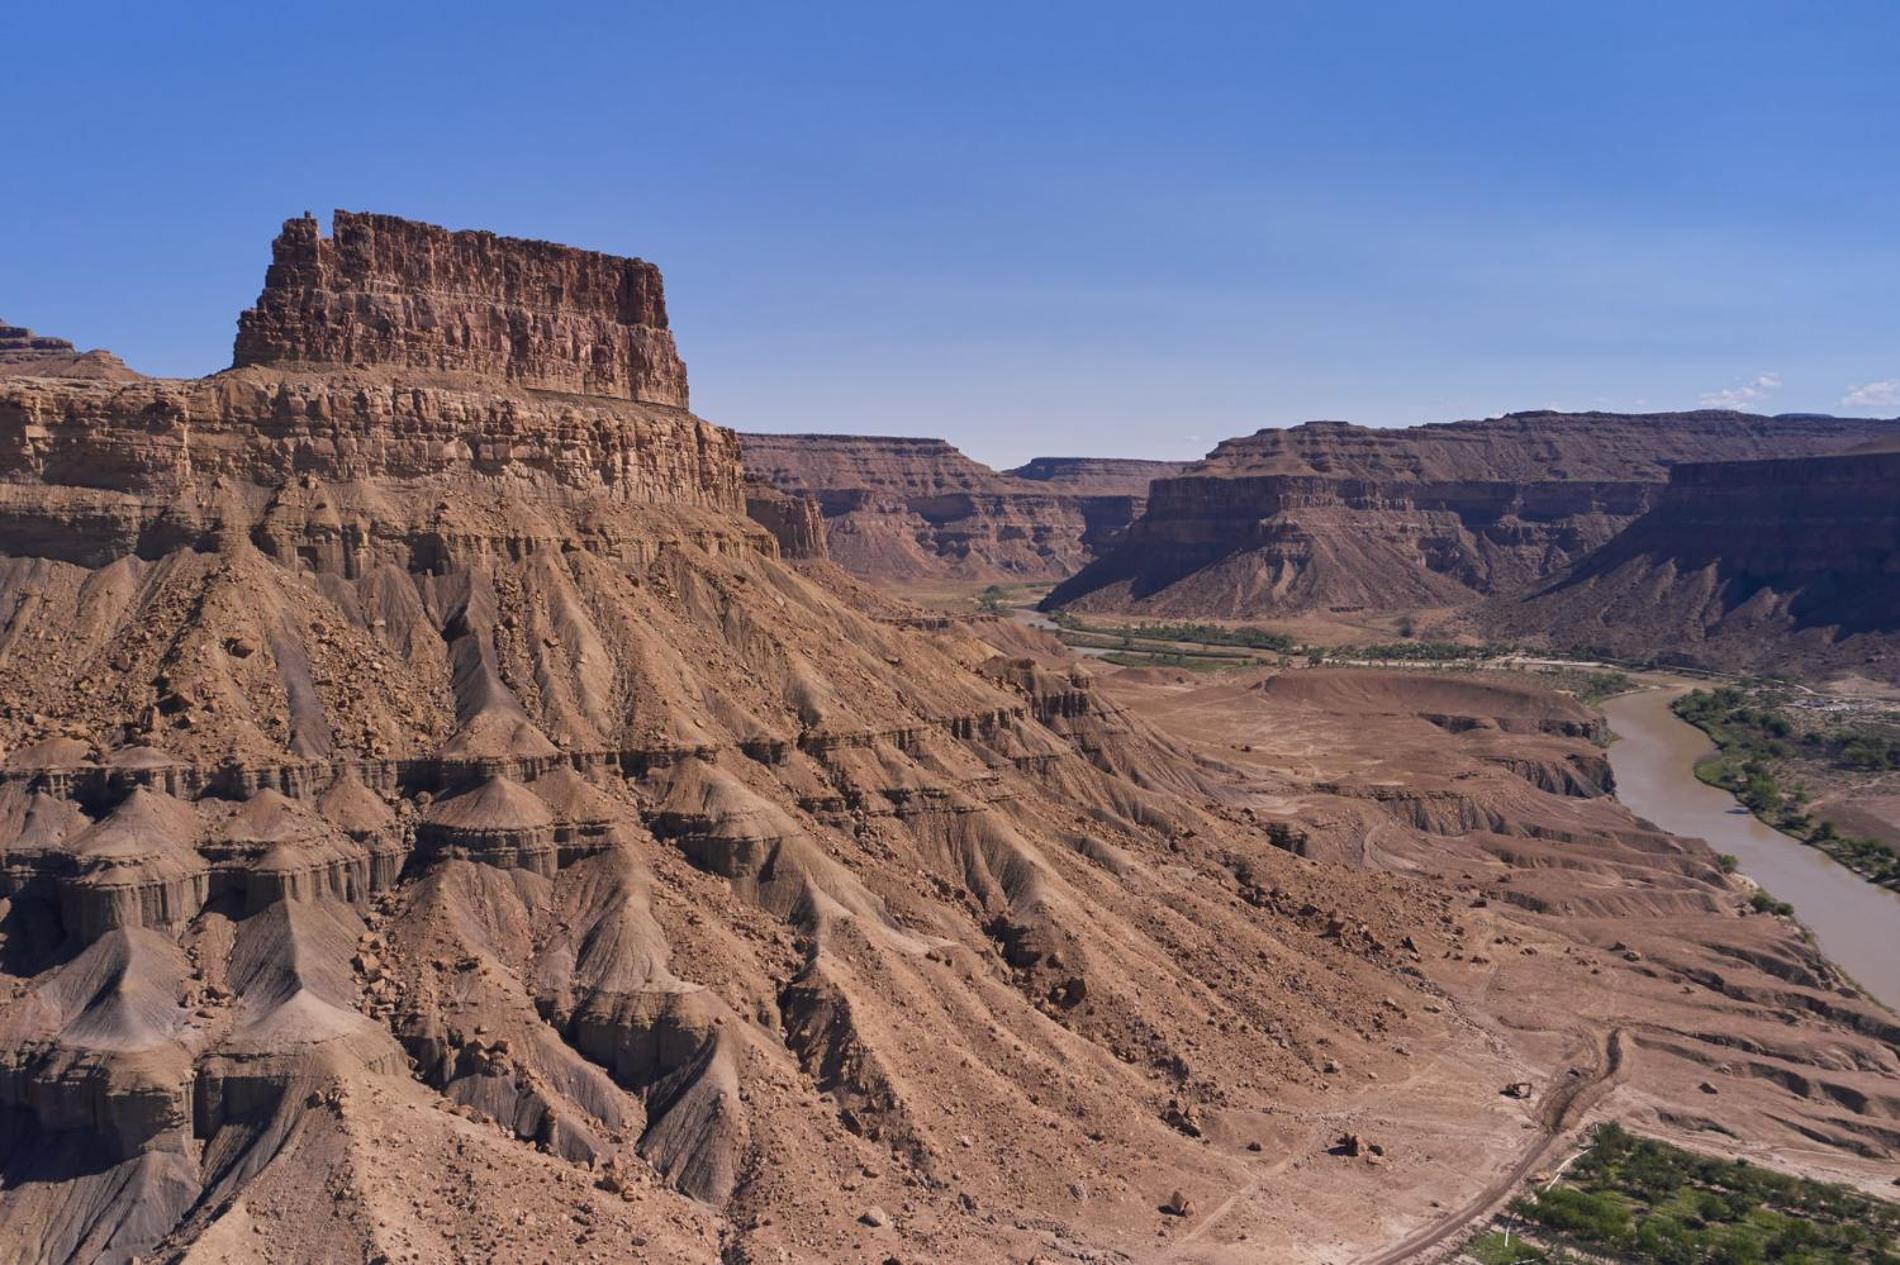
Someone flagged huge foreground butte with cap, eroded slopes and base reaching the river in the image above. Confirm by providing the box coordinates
[0,215,1900,1265]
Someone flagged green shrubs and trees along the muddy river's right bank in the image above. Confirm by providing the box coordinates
[1676,686,1900,887]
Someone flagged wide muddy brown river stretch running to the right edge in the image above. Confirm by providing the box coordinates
[1604,686,1900,1010]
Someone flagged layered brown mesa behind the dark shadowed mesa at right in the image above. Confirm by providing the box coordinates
[1049,412,1896,615]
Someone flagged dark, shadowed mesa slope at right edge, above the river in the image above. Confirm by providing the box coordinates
[1478,444,1900,676]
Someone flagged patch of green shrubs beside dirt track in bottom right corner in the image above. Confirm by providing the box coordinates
[1489,1124,1900,1265]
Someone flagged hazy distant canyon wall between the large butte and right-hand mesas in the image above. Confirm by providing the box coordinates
[739,435,1178,583]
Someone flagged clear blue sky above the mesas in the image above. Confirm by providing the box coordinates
[0,0,1900,463]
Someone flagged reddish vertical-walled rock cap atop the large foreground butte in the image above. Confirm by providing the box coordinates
[234,211,686,400]
